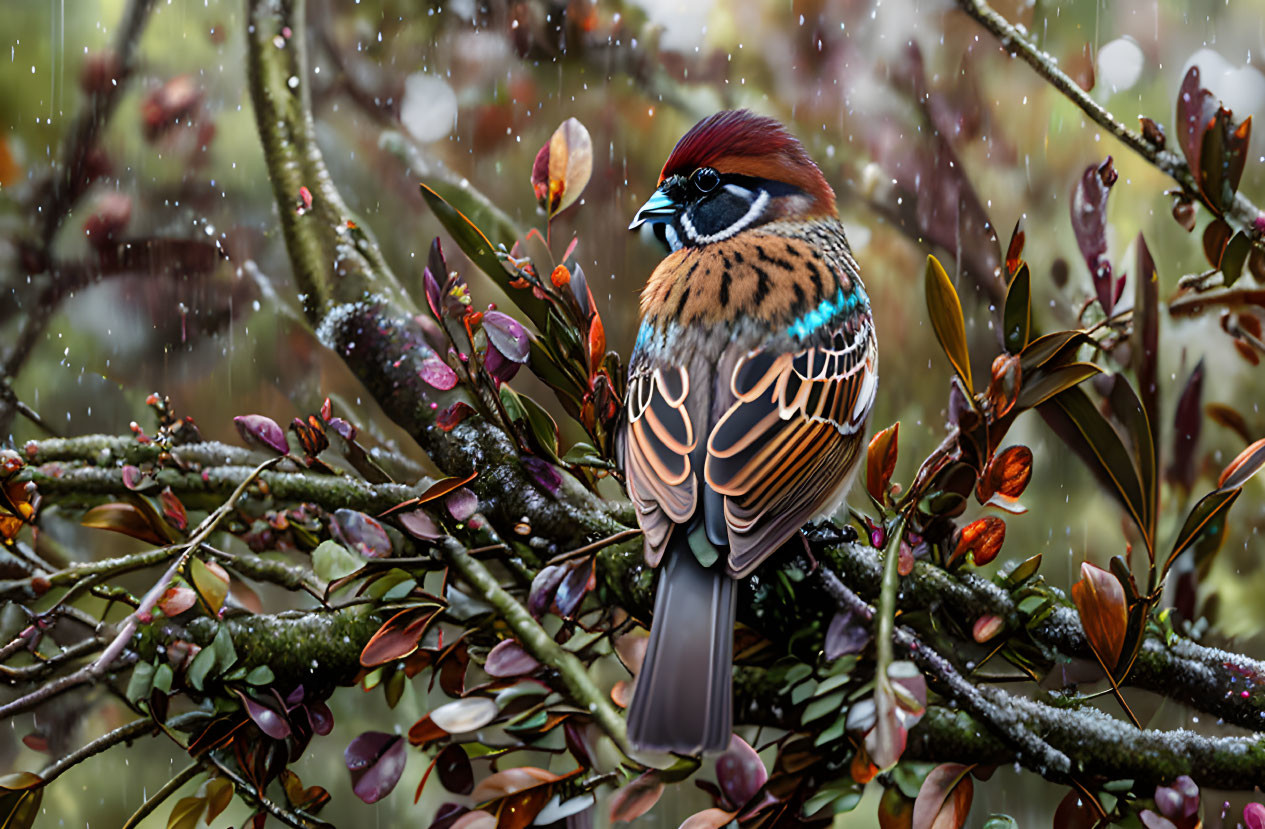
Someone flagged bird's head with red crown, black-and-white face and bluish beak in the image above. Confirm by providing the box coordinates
[629,109,837,251]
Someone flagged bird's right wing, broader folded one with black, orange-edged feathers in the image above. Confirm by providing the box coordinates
[705,314,878,576]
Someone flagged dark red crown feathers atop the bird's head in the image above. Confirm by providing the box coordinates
[659,109,836,215]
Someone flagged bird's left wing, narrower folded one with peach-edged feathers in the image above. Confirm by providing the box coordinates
[622,363,698,567]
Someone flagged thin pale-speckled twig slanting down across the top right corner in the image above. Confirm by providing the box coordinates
[958,0,1262,239]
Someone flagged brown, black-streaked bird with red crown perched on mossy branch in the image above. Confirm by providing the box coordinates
[616,110,878,754]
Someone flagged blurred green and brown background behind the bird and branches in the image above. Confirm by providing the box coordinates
[0,0,1265,826]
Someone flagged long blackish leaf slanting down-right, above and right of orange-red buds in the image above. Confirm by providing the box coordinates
[1041,389,1147,533]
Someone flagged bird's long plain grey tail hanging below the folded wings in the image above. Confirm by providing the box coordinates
[629,528,736,754]
